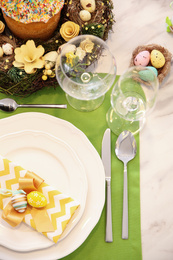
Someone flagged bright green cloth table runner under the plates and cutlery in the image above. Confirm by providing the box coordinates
[0,80,142,260]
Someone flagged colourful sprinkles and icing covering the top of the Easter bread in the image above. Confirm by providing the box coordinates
[0,0,64,23]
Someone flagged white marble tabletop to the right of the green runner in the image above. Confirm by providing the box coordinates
[108,0,173,260]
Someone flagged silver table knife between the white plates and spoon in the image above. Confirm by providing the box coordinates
[102,128,113,242]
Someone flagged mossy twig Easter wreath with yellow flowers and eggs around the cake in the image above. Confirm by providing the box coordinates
[0,0,115,96]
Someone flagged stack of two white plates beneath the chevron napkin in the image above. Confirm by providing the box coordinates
[0,112,105,260]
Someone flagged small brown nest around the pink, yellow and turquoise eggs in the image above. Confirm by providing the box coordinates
[130,44,172,83]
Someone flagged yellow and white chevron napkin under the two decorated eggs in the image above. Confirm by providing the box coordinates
[0,156,79,243]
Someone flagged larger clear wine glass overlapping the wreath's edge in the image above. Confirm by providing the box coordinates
[56,35,116,111]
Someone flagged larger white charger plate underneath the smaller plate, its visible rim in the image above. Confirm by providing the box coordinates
[0,112,105,260]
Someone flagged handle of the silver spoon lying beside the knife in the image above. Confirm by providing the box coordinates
[122,163,128,239]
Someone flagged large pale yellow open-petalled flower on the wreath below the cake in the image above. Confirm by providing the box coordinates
[13,40,45,74]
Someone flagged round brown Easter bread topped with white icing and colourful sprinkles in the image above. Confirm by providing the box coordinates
[0,0,64,40]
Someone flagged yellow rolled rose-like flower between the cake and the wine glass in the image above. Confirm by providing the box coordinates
[60,21,80,42]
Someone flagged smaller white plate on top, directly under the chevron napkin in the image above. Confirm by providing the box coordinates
[0,130,88,251]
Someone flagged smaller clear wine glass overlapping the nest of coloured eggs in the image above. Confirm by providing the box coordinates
[106,66,159,135]
